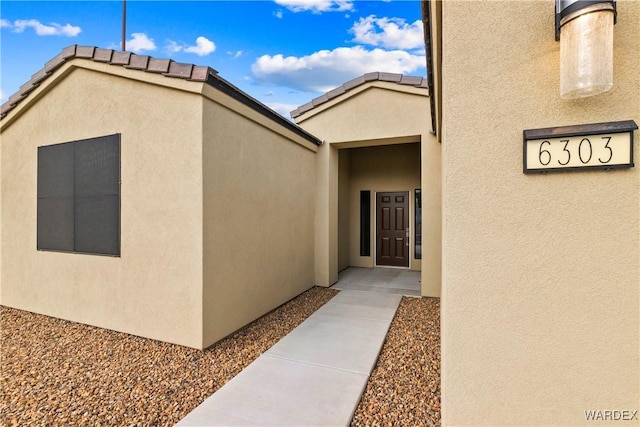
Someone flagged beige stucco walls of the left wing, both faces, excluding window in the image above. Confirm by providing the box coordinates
[0,59,316,348]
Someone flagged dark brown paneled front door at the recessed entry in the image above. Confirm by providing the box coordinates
[376,192,409,267]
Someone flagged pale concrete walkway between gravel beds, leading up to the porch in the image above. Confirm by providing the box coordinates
[177,290,402,426]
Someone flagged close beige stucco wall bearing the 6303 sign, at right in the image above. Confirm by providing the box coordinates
[441,1,640,426]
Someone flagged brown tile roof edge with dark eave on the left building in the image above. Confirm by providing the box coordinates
[0,45,322,145]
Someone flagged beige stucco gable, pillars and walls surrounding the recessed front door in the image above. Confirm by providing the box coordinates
[295,81,441,296]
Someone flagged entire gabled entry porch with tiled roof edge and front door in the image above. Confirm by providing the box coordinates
[292,72,442,297]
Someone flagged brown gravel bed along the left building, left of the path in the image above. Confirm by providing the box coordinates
[0,287,337,426]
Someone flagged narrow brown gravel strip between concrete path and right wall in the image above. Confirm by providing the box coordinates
[351,297,440,427]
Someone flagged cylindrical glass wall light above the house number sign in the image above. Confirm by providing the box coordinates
[556,0,617,99]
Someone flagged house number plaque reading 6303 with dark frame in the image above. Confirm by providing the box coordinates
[523,120,638,173]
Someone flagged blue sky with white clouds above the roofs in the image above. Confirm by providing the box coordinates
[0,0,426,117]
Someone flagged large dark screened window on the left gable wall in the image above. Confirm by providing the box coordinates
[38,134,120,256]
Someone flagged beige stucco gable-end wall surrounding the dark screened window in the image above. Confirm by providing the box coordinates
[1,65,202,347]
